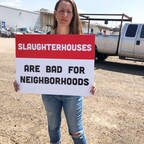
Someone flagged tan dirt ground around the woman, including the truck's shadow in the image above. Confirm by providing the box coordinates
[0,38,144,144]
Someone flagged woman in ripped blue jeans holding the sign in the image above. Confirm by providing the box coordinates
[14,0,96,144]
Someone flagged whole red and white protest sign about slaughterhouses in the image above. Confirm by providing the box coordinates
[16,35,95,96]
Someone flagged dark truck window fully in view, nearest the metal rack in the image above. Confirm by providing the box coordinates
[125,24,138,37]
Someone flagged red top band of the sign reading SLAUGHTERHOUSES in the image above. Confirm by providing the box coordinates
[16,35,95,59]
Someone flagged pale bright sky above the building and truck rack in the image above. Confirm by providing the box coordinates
[0,0,144,23]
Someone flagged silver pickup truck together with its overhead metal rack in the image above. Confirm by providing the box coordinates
[80,13,144,61]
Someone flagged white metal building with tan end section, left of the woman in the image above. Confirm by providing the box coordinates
[0,5,53,31]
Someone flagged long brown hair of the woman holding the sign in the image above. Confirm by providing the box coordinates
[53,0,82,34]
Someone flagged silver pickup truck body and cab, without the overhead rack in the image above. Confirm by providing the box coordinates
[96,23,144,61]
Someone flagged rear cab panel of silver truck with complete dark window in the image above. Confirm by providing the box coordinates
[119,24,138,57]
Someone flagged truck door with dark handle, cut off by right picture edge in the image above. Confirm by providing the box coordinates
[134,24,144,59]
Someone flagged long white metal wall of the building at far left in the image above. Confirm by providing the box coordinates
[0,5,41,29]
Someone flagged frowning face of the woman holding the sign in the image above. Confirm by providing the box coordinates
[54,1,73,26]
